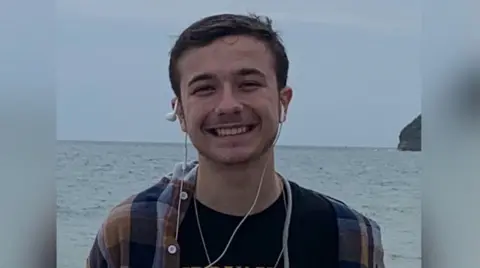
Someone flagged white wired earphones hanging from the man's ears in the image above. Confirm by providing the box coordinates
[165,99,293,268]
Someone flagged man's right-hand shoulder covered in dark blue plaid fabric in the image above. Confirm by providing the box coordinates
[286,183,385,268]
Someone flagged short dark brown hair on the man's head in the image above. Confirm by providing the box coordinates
[168,14,289,98]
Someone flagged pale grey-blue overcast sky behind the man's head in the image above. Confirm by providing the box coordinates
[56,0,421,147]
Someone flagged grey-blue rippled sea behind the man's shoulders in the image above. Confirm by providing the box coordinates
[56,141,422,268]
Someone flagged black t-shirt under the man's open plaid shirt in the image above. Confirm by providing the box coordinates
[179,182,338,268]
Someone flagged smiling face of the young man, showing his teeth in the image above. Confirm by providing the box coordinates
[174,36,292,165]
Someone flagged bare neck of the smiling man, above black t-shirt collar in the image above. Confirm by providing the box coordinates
[196,150,283,216]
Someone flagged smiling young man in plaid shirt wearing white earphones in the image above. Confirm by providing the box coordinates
[87,14,384,268]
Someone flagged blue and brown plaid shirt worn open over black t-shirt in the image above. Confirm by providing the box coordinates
[86,162,385,268]
